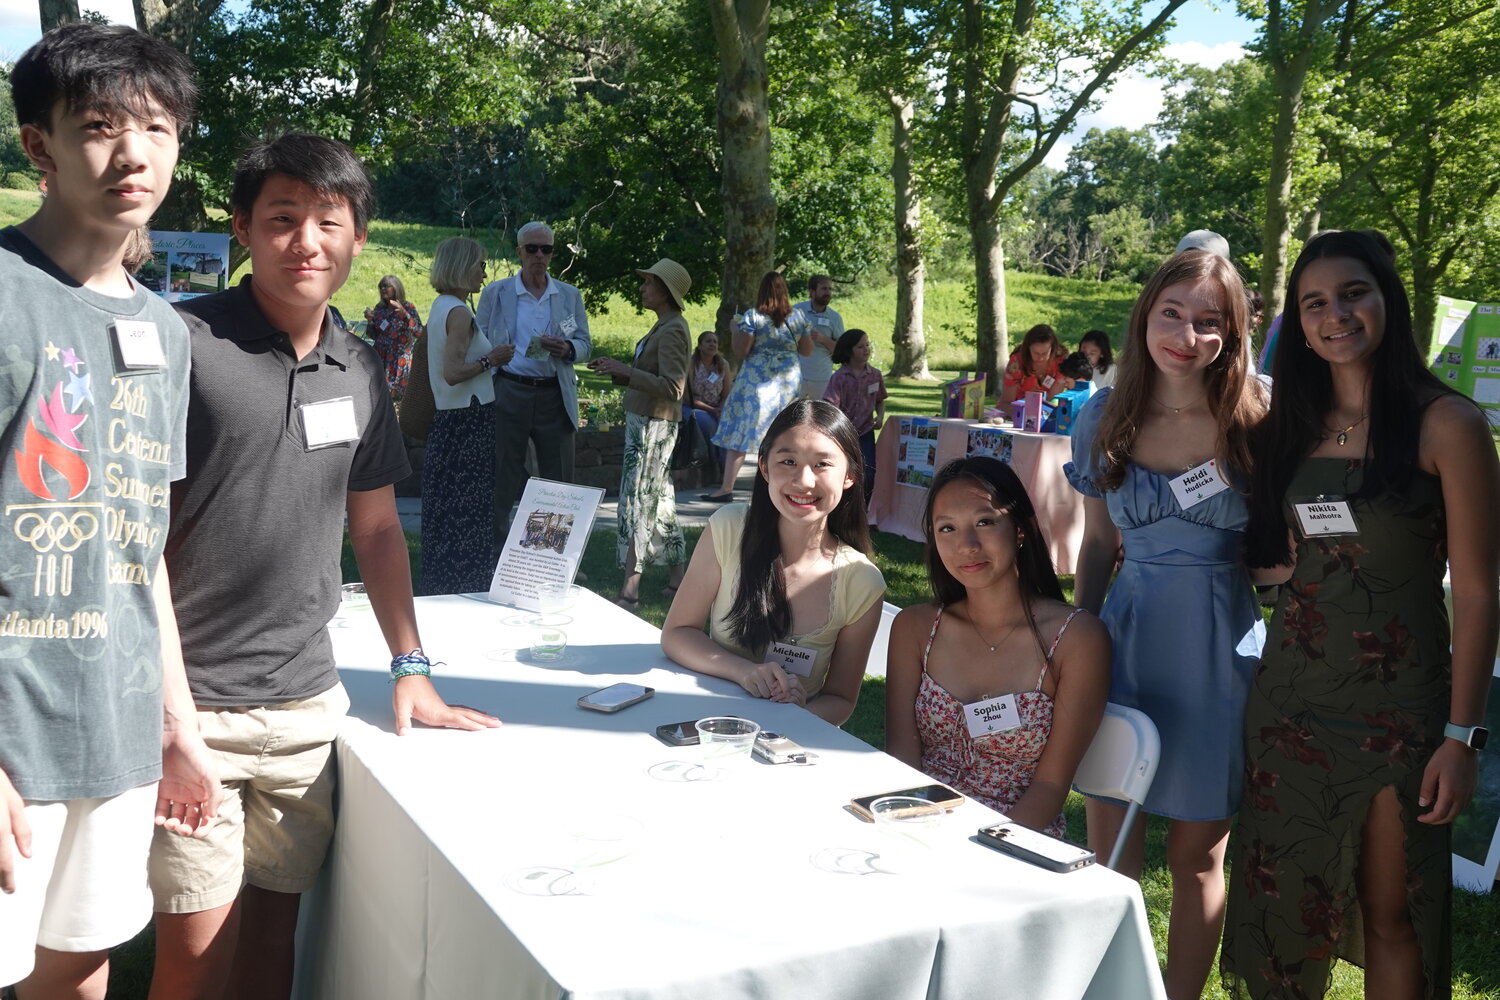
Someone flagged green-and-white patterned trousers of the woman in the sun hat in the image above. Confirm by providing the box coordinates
[618,412,687,573]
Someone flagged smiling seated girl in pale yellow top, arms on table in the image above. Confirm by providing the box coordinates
[662,399,885,726]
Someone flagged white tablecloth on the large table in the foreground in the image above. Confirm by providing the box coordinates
[300,594,1163,1000]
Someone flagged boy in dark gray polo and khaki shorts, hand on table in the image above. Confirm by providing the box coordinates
[152,133,500,1000]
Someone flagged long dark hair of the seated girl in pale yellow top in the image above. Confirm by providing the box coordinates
[728,401,870,655]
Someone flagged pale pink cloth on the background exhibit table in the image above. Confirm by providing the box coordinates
[870,417,1083,573]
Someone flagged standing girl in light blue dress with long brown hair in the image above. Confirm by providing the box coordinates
[1067,250,1266,1000]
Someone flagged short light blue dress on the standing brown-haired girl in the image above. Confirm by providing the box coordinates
[1065,388,1266,820]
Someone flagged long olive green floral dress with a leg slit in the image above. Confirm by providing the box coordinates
[1223,459,1452,1000]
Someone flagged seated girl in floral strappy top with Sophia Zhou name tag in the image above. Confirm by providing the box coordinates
[885,457,1110,837]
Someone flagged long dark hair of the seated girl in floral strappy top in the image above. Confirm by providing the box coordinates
[923,456,1065,658]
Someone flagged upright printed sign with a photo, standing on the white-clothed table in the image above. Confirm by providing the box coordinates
[489,477,605,612]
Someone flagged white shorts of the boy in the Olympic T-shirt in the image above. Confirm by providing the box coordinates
[0,781,156,985]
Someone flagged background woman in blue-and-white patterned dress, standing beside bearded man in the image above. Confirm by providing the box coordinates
[701,271,813,504]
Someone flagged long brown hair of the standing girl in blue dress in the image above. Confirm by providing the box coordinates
[1094,250,1266,490]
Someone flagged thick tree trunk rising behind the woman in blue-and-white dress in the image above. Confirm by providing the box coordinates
[708,0,776,343]
